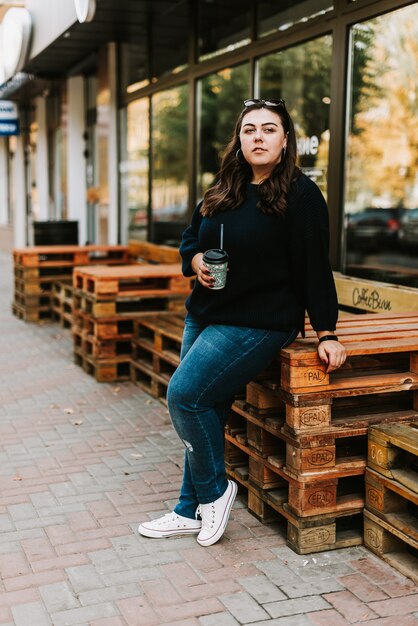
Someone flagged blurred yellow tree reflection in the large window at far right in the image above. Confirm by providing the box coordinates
[347,5,418,211]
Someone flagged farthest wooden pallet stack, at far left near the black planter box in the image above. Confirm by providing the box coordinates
[12,246,129,323]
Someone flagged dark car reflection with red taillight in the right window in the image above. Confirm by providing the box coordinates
[347,207,402,250]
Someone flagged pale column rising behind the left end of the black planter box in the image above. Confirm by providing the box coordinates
[36,97,50,220]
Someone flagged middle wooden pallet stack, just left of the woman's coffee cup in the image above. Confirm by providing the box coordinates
[73,264,191,382]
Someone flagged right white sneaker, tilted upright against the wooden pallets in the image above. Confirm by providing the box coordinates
[197,480,238,546]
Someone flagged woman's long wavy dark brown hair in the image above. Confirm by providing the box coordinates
[201,102,300,216]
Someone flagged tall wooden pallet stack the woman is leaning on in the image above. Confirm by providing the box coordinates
[225,314,418,554]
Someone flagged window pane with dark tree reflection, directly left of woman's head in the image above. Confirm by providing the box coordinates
[197,63,250,200]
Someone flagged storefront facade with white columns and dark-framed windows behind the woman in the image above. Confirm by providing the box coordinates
[0,0,418,286]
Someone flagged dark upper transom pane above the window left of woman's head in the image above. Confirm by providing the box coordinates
[198,0,253,61]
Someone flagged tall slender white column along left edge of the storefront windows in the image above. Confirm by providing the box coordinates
[107,43,119,245]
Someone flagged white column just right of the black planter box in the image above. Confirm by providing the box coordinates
[67,76,87,245]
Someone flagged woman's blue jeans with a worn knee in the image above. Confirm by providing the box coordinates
[167,314,298,519]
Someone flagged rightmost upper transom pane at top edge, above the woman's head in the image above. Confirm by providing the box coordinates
[258,0,333,36]
